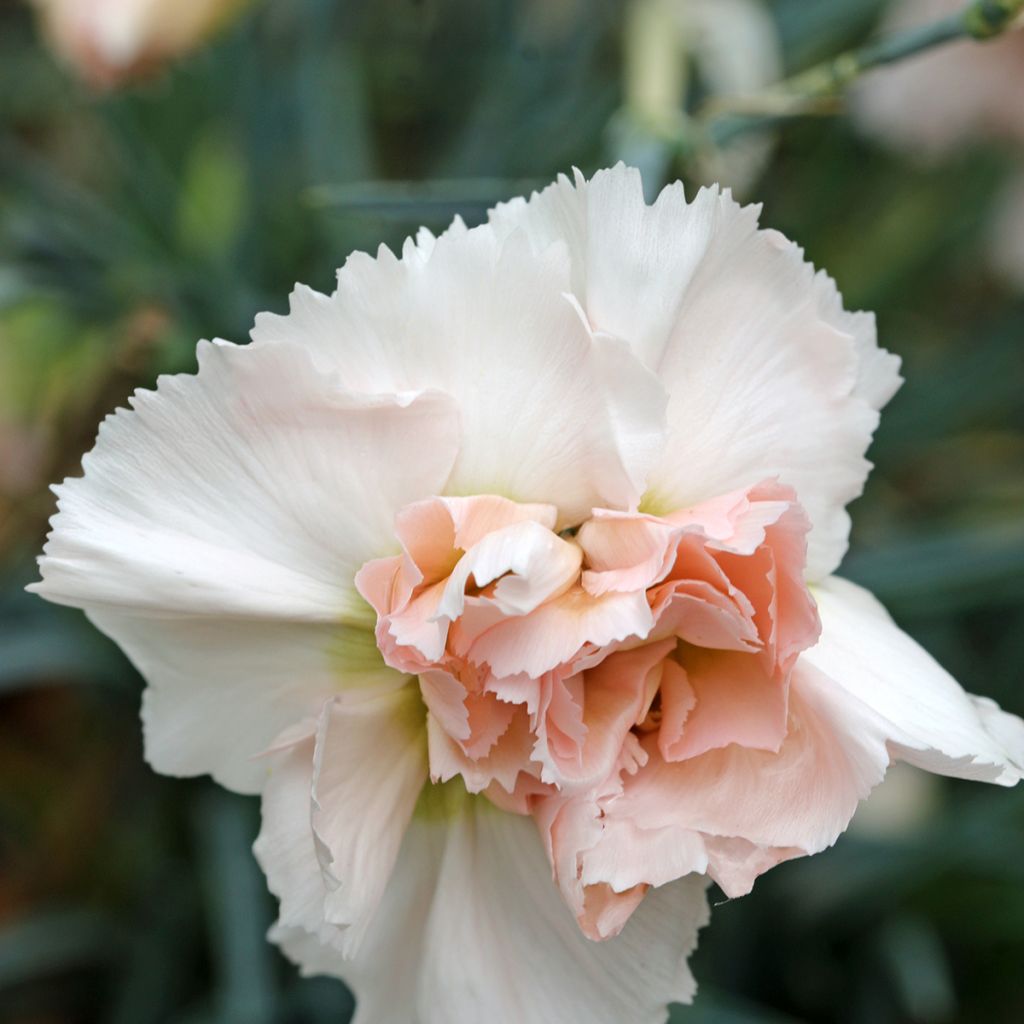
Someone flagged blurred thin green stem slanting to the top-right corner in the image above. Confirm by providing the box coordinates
[700,0,1024,145]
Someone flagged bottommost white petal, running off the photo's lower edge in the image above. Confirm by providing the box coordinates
[273,803,708,1024]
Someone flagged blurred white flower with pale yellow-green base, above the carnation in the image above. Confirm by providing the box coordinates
[613,0,782,193]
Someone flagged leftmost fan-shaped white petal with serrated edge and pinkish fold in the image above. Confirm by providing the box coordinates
[31,342,458,623]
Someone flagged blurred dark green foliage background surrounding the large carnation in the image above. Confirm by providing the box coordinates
[0,0,1024,1024]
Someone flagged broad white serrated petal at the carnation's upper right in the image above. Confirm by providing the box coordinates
[493,166,899,579]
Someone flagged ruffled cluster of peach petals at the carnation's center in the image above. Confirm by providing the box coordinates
[356,480,819,938]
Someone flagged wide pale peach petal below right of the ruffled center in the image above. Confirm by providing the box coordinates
[535,671,888,925]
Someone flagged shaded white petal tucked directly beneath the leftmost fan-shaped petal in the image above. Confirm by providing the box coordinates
[89,609,406,793]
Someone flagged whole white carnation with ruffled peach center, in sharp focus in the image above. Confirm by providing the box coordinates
[35,166,1024,1024]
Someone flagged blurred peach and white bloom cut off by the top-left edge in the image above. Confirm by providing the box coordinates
[35,0,247,88]
